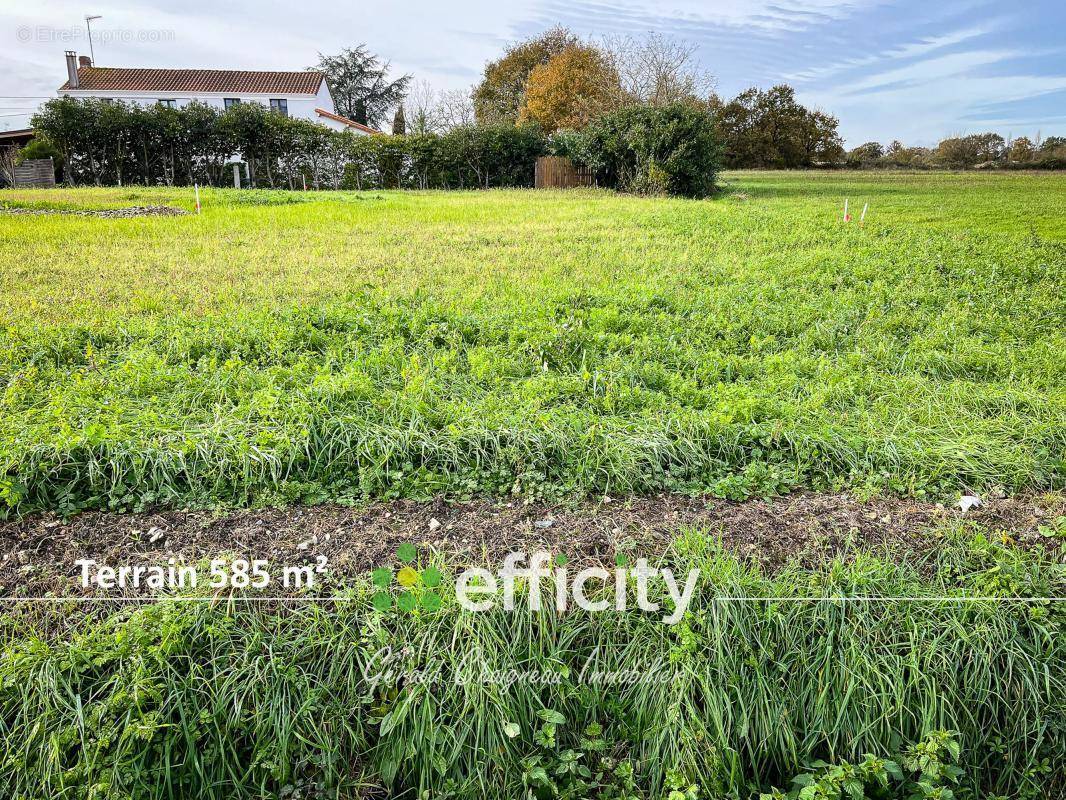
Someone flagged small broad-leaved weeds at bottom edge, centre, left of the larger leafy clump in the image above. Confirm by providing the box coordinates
[513,708,699,800]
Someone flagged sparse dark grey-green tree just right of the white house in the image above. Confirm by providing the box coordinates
[310,45,411,128]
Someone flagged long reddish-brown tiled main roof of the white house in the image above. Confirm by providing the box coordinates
[60,67,322,95]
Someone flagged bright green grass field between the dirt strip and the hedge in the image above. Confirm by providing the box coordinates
[0,173,1066,511]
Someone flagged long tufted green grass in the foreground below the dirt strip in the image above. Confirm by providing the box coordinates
[0,530,1066,800]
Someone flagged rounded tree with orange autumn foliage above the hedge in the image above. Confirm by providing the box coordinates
[518,45,621,132]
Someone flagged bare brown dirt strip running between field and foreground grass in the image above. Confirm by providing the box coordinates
[0,493,1066,597]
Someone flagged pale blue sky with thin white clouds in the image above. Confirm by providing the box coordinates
[0,0,1066,147]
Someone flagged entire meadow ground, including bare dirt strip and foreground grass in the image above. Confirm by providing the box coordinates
[0,172,1066,800]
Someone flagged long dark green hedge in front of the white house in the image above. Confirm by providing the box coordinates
[33,98,548,189]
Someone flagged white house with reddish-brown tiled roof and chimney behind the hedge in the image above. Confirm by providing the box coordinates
[59,50,381,135]
